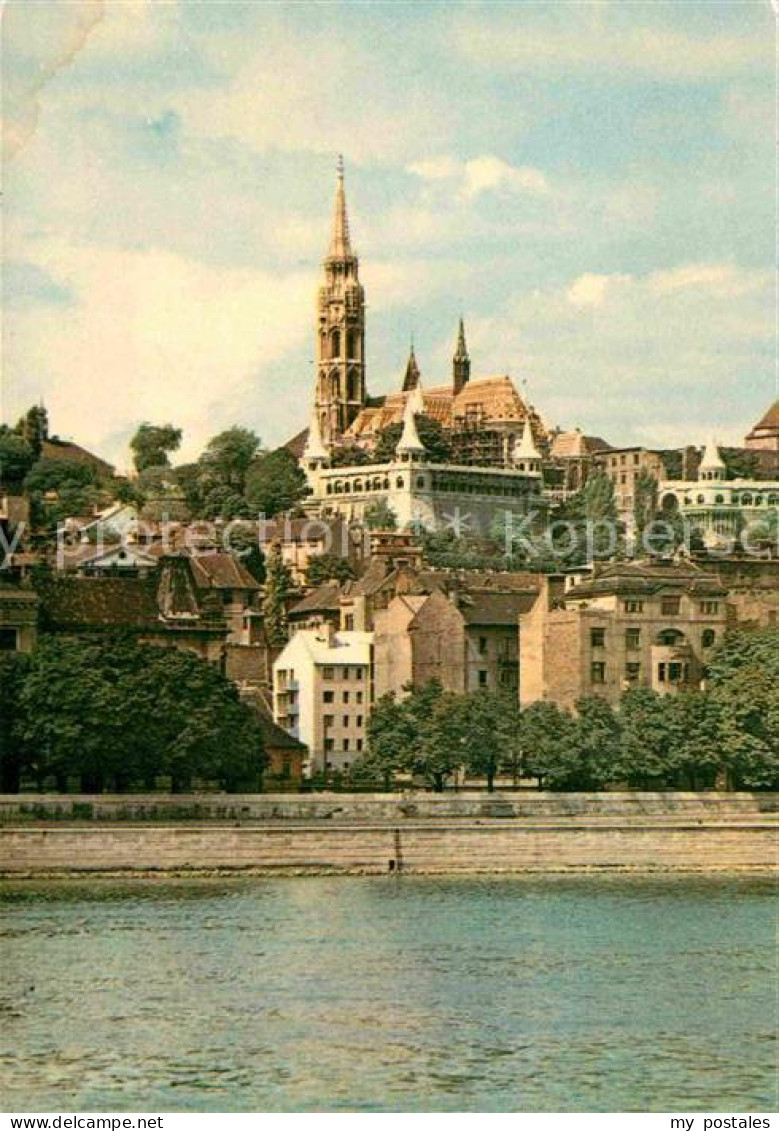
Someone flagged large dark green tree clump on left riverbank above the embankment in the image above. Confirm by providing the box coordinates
[0,636,265,791]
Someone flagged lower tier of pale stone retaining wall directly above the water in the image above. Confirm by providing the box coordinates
[0,819,777,877]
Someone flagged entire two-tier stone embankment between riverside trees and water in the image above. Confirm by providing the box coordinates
[0,792,779,877]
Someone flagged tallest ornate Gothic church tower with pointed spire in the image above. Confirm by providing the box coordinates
[317,157,365,446]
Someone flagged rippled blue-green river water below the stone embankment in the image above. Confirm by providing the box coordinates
[0,875,777,1113]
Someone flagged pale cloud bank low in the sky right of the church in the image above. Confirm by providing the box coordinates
[461,264,774,444]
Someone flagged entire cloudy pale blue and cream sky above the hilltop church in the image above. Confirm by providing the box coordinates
[1,0,777,468]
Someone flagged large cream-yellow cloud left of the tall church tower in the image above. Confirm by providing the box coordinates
[5,241,312,460]
